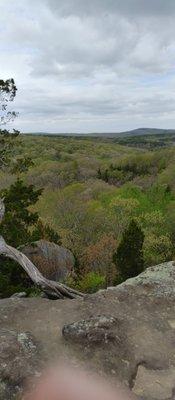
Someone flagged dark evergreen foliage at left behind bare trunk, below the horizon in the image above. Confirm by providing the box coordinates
[0,178,60,297]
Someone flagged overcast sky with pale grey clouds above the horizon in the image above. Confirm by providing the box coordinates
[0,0,175,133]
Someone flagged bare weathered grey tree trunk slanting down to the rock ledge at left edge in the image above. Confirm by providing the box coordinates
[0,236,84,299]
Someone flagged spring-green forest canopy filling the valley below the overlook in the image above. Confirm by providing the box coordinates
[0,123,175,292]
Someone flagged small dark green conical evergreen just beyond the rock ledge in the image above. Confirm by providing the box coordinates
[114,220,144,280]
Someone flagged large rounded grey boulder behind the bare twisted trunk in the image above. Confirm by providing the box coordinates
[21,240,75,281]
